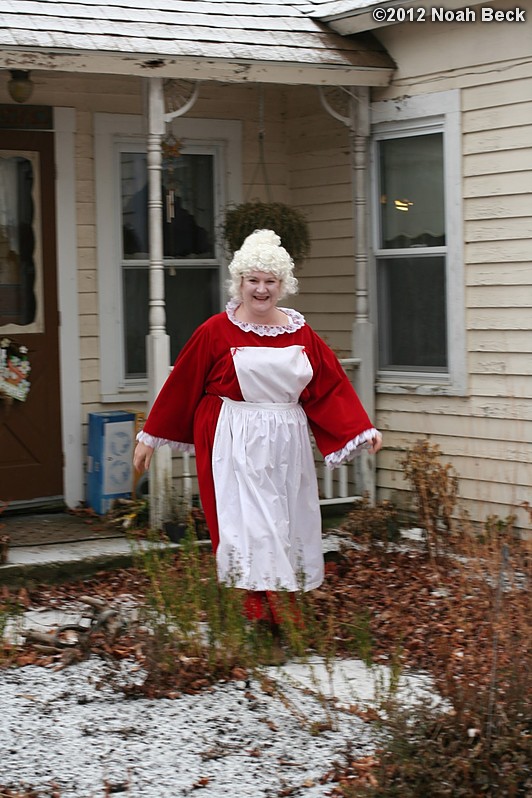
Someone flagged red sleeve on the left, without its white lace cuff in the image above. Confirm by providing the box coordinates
[143,322,214,443]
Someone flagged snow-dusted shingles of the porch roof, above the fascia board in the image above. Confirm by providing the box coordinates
[0,0,393,83]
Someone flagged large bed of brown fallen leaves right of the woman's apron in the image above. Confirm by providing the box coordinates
[314,548,530,684]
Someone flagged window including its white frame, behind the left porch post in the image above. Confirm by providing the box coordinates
[95,114,240,401]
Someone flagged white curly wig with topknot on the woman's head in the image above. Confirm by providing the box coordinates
[228,230,297,300]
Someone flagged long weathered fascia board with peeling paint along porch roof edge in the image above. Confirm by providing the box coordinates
[0,48,393,86]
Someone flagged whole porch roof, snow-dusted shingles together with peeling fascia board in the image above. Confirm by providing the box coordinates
[0,0,395,86]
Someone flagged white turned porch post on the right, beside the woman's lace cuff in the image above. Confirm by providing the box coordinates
[350,87,376,502]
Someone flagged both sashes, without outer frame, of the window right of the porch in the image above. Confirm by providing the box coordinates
[377,132,448,372]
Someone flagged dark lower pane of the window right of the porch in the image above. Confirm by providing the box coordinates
[378,257,447,371]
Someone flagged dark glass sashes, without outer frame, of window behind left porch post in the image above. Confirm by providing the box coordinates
[119,145,220,380]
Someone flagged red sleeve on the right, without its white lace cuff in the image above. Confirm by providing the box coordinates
[301,328,373,457]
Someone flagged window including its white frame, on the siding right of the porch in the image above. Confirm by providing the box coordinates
[372,92,465,393]
